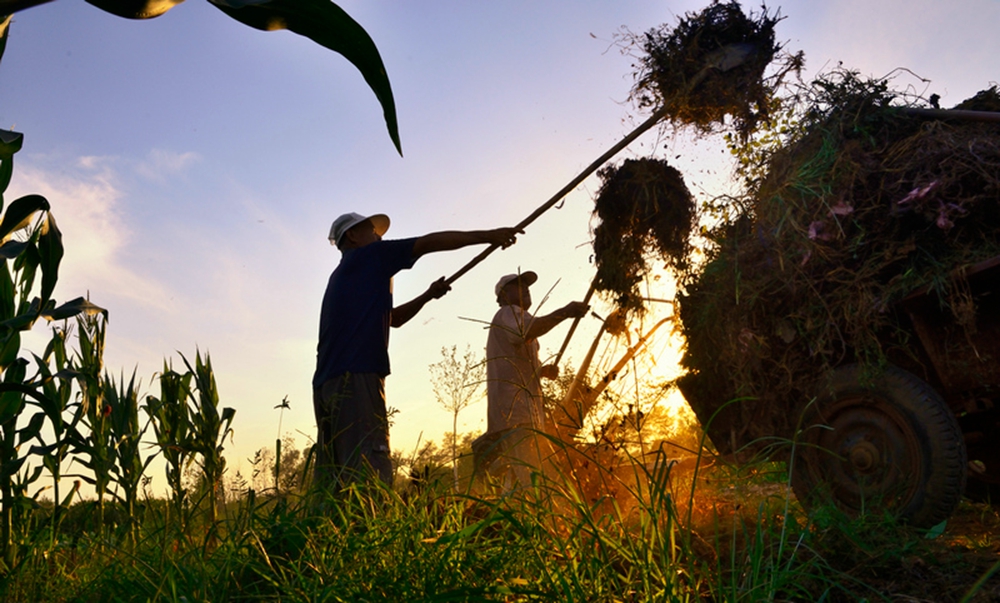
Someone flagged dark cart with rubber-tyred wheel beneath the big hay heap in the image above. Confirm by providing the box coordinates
[682,256,1000,526]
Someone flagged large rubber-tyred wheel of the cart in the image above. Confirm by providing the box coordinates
[792,365,966,527]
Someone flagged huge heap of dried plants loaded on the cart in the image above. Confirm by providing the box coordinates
[679,72,1000,450]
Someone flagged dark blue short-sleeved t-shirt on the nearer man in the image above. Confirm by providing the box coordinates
[313,238,416,387]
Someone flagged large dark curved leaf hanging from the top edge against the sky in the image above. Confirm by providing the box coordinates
[209,0,403,155]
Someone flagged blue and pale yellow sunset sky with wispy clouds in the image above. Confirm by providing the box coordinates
[0,0,1000,488]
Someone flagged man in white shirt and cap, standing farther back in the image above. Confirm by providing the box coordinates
[486,271,590,490]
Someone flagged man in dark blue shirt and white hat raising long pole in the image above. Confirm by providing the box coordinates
[313,213,518,488]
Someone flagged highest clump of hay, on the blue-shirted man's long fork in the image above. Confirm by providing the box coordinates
[631,0,803,139]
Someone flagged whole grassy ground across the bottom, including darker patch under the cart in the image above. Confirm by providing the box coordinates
[0,446,1000,602]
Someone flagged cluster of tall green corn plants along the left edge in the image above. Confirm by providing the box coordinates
[0,137,247,575]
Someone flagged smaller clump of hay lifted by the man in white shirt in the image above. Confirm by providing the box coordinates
[594,159,696,316]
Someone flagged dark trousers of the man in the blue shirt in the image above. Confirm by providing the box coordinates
[313,373,393,488]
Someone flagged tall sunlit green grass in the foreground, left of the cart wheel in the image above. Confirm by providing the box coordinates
[0,434,868,601]
